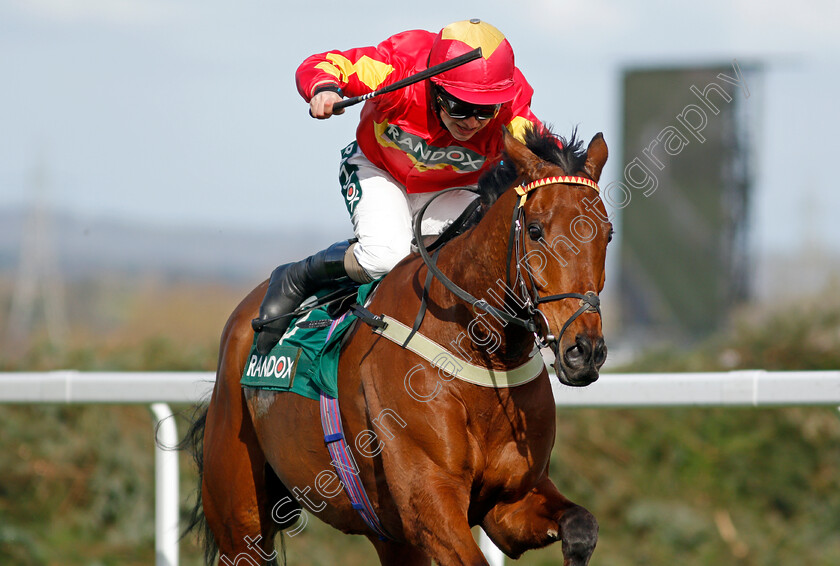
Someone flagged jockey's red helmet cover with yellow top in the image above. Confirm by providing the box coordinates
[429,19,516,104]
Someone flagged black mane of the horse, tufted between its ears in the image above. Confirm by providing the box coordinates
[478,126,586,211]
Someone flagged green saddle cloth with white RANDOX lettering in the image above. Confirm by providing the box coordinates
[240,281,378,399]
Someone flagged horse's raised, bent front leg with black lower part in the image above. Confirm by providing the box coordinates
[481,477,598,566]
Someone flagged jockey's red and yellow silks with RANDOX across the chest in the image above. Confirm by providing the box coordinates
[296,30,542,193]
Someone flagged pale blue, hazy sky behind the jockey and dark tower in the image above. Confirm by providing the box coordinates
[0,0,840,262]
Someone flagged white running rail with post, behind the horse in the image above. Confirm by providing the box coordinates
[0,370,840,566]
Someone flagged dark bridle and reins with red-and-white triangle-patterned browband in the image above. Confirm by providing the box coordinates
[414,175,601,355]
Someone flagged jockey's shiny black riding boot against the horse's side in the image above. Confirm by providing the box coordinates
[251,240,350,355]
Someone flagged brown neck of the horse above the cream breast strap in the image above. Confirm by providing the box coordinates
[430,191,533,369]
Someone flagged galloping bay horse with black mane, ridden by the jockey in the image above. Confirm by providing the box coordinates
[190,131,612,566]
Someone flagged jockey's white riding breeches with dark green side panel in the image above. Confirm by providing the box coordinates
[339,142,478,279]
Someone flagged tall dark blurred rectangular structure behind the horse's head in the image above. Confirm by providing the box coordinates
[616,65,758,343]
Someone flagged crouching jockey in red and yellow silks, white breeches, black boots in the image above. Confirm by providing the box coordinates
[252,19,541,353]
